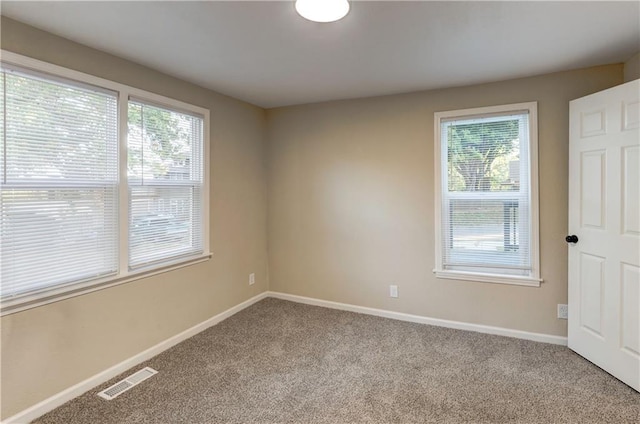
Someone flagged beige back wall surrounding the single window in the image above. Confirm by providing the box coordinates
[267,65,622,336]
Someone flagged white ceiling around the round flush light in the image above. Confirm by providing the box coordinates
[2,0,640,107]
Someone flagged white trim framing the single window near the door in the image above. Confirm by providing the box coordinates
[433,102,542,287]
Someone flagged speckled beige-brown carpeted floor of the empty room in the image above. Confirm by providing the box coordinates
[36,299,640,424]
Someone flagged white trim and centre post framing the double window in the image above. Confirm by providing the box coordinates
[0,50,212,316]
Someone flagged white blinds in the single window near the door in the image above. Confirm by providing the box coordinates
[440,111,533,277]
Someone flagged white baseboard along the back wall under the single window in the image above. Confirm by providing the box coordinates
[267,291,567,346]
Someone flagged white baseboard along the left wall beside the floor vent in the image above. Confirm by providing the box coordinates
[2,292,268,424]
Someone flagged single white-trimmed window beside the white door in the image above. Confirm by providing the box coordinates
[434,102,541,286]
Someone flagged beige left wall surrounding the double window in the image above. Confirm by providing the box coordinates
[0,17,268,418]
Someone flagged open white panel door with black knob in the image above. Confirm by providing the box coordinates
[567,80,640,391]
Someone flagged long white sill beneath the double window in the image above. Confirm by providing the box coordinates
[0,253,211,316]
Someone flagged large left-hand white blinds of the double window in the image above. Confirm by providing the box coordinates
[0,67,118,299]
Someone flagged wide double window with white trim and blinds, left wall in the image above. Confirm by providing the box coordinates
[0,52,209,313]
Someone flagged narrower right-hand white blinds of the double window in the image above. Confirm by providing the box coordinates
[127,99,203,269]
